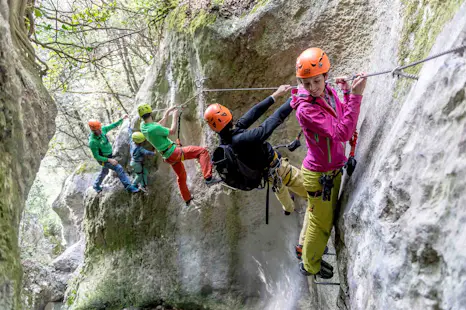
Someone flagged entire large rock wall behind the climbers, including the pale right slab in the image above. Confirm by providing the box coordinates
[65,0,466,309]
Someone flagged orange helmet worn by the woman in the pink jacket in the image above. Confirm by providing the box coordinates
[296,47,330,79]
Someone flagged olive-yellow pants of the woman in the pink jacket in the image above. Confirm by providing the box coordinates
[301,167,341,274]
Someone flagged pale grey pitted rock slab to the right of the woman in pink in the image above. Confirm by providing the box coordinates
[338,4,466,309]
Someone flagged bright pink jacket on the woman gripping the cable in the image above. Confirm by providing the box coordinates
[291,85,362,172]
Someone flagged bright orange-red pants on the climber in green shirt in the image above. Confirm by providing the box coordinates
[165,146,212,201]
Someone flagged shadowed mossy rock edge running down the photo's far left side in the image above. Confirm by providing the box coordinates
[0,0,56,309]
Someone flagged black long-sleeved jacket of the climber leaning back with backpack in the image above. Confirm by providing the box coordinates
[221,96,293,169]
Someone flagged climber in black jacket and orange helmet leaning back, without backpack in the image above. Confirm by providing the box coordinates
[204,85,307,215]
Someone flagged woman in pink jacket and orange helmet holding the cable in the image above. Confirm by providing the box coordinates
[291,48,366,279]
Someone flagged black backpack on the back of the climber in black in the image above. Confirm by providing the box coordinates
[212,144,267,191]
